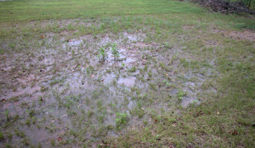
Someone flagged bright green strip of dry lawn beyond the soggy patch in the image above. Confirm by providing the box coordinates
[0,0,203,22]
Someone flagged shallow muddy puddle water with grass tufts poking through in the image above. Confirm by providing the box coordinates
[0,32,217,147]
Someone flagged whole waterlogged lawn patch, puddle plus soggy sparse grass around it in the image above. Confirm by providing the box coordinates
[0,18,253,147]
